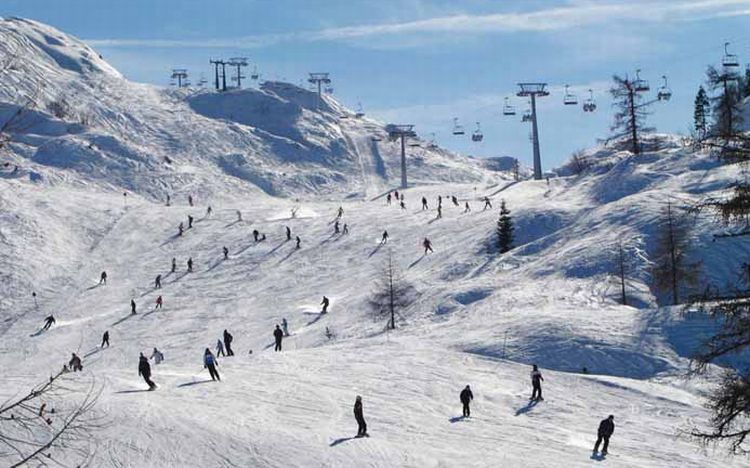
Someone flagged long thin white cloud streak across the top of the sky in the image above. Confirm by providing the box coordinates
[87,0,750,48]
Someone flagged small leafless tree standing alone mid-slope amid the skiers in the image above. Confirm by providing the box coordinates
[369,249,417,330]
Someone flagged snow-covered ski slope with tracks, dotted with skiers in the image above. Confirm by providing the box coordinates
[0,16,750,467]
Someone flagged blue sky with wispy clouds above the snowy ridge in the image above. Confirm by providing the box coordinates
[0,0,750,168]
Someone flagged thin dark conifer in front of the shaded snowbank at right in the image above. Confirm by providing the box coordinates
[651,202,699,305]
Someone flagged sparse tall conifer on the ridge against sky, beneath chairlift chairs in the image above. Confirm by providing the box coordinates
[609,75,654,154]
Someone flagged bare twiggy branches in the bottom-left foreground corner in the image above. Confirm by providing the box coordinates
[0,370,103,468]
